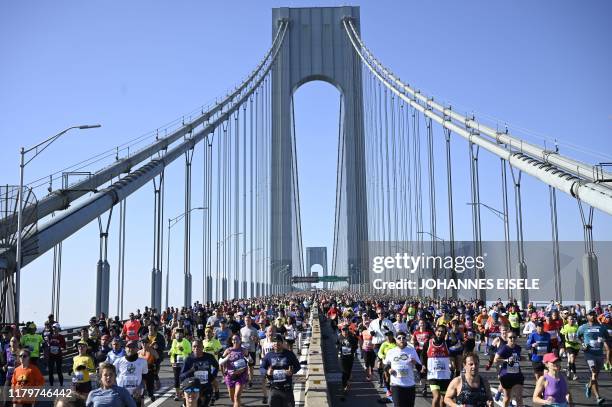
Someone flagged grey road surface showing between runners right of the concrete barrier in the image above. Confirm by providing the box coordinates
[321,321,612,407]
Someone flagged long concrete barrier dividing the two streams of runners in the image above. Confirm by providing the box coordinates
[304,304,330,407]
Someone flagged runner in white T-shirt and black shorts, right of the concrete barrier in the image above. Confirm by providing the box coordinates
[384,332,421,407]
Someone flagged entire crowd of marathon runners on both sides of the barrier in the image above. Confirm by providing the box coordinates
[0,292,612,407]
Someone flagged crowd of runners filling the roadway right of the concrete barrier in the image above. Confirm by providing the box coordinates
[320,293,612,407]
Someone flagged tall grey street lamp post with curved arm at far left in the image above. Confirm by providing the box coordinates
[15,124,102,324]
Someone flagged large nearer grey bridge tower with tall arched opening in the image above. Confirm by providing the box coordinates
[269,7,368,286]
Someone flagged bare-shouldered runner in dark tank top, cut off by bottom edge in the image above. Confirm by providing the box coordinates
[444,353,493,407]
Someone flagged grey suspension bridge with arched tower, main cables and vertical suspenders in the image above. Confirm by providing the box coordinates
[0,7,612,322]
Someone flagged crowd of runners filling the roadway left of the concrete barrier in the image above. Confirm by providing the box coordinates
[0,294,312,407]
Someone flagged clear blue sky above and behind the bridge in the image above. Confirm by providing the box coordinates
[0,0,612,324]
